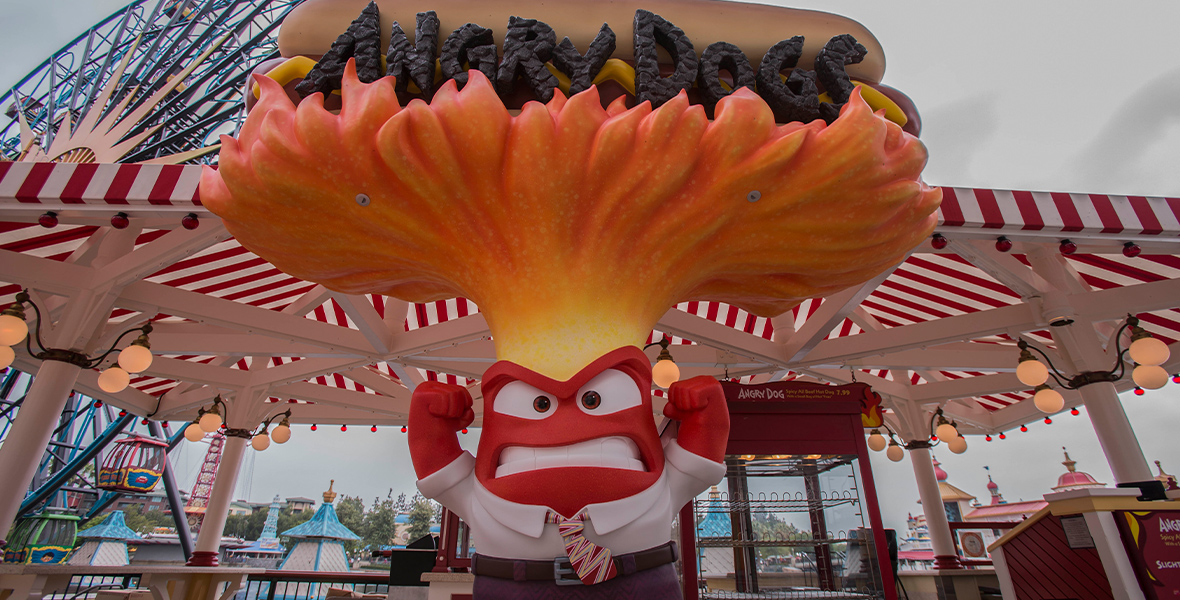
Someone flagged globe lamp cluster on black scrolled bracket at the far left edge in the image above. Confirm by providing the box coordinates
[0,289,152,393]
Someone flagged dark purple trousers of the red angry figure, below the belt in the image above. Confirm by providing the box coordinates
[474,563,683,600]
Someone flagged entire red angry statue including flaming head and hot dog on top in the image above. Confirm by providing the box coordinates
[201,0,940,600]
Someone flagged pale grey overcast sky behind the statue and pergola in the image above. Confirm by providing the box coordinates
[0,0,1180,530]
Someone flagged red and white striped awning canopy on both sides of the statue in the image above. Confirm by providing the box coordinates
[0,163,1180,431]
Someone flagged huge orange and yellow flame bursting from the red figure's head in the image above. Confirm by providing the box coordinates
[201,65,940,379]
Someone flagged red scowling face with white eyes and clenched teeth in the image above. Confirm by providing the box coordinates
[476,346,664,516]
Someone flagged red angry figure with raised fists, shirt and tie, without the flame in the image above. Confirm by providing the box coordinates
[409,346,729,600]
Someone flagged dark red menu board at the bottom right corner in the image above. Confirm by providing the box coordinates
[1114,510,1180,600]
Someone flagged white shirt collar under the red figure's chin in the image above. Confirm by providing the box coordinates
[474,469,668,537]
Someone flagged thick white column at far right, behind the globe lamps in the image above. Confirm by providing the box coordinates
[1049,321,1152,483]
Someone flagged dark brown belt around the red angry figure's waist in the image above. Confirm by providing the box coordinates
[471,542,676,586]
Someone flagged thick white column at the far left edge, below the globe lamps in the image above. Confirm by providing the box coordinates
[0,360,81,540]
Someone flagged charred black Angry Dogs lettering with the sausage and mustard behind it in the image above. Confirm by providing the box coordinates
[251,2,918,130]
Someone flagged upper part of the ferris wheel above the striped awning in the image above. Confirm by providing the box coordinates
[0,0,299,164]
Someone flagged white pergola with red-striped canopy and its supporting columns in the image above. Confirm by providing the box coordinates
[0,163,1180,566]
